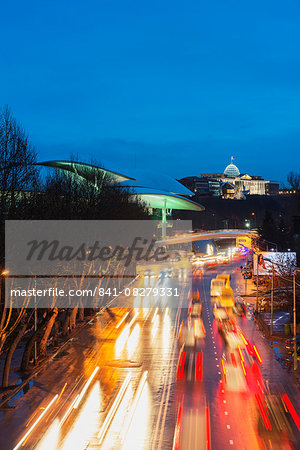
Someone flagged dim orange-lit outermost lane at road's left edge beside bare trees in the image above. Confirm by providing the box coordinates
[0,308,119,448]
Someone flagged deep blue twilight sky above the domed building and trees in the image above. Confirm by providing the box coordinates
[0,0,300,181]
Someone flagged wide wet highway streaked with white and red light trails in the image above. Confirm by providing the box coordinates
[0,262,299,450]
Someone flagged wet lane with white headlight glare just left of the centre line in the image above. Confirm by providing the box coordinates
[98,284,188,449]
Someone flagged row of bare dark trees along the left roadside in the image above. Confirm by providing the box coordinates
[0,107,149,388]
